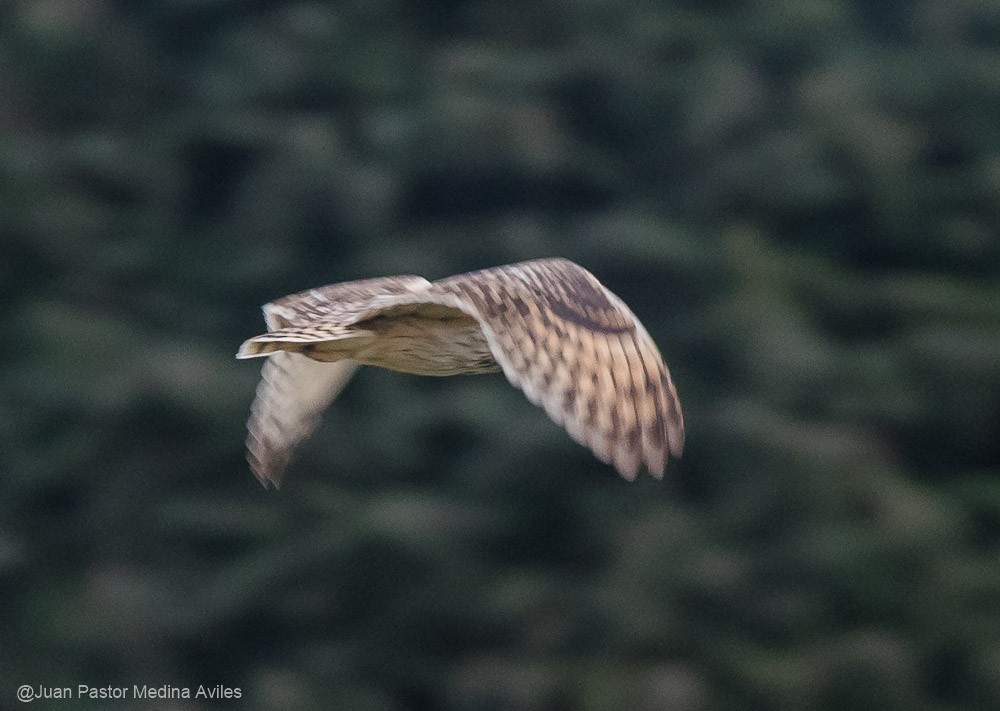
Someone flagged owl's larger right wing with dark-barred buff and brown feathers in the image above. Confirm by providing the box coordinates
[422,259,684,479]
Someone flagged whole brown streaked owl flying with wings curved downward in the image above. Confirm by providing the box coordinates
[237,259,684,487]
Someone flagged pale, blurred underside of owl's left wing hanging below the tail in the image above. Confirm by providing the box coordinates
[247,351,357,489]
